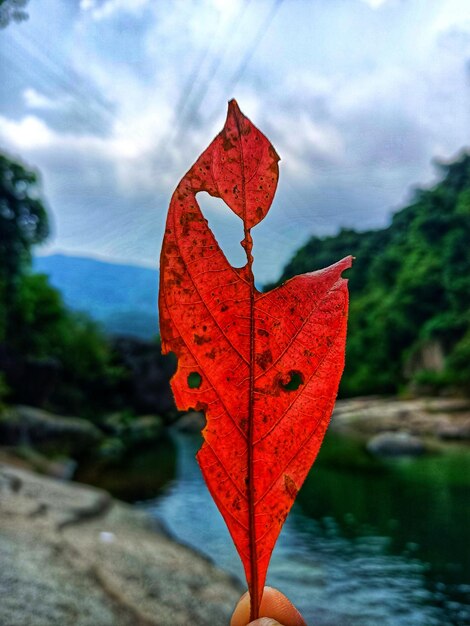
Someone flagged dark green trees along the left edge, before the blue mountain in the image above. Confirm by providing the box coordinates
[0,154,122,415]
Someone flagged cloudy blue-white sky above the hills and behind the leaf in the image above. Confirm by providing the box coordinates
[0,0,470,282]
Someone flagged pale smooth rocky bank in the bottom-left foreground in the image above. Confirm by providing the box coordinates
[0,464,242,626]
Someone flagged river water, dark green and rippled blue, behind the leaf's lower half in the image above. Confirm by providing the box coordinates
[141,434,470,626]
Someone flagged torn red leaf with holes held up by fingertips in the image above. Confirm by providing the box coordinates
[159,100,351,619]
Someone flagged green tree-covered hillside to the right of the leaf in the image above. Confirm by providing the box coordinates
[270,154,470,395]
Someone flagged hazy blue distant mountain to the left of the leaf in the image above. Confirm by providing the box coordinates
[33,254,159,338]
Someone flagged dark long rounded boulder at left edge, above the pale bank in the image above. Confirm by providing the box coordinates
[0,405,103,457]
